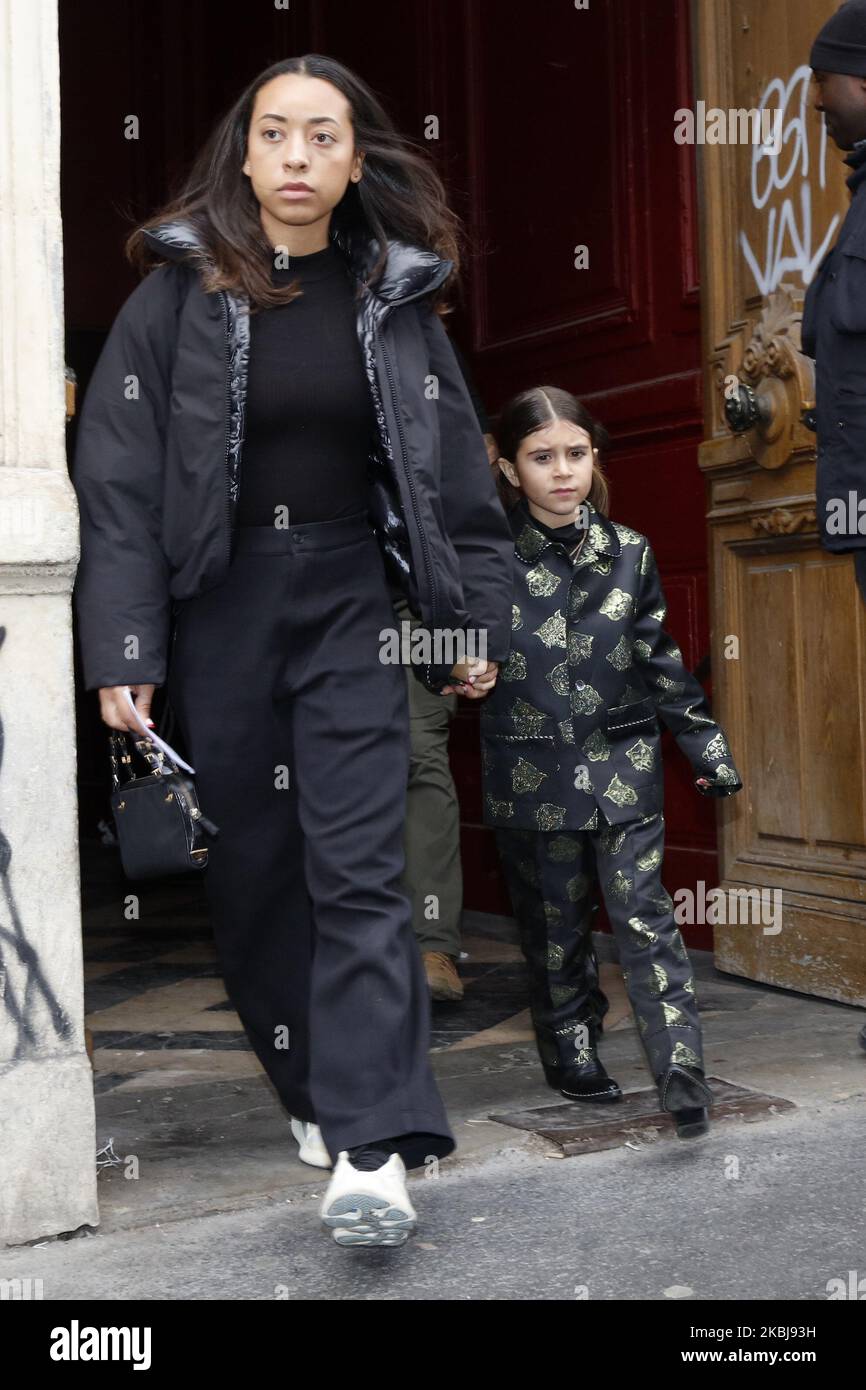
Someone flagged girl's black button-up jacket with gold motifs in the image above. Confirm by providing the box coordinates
[481,498,741,830]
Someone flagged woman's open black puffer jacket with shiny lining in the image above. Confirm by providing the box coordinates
[72,222,513,689]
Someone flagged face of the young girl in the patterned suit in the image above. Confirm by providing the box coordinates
[499,420,598,527]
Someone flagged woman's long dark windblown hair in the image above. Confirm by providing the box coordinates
[124,53,463,313]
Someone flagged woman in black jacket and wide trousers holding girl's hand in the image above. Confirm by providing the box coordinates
[74,54,510,1244]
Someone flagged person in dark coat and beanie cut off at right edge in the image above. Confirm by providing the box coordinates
[801,0,866,1048]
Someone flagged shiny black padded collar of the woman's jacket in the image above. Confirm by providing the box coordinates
[145,220,453,304]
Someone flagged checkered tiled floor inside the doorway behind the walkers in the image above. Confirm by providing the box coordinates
[83,828,631,1093]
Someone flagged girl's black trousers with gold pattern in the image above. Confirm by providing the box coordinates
[496,813,703,1080]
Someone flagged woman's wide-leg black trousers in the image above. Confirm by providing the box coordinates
[167,513,455,1168]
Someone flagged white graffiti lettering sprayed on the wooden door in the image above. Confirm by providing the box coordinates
[740,64,840,295]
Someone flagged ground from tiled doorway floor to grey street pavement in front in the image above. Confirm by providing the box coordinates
[0,872,866,1300]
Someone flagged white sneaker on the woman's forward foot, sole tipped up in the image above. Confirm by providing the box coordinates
[320,1150,417,1245]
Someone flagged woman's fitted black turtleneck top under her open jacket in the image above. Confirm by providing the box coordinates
[238,242,375,525]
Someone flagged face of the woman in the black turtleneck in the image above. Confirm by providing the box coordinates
[243,72,364,248]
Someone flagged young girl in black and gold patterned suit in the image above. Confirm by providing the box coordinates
[481,386,741,1137]
